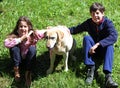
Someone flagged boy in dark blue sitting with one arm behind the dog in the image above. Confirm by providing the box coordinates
[70,3,118,88]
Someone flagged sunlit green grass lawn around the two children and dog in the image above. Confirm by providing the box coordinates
[0,0,120,88]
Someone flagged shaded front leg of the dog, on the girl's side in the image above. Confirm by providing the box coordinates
[47,51,56,75]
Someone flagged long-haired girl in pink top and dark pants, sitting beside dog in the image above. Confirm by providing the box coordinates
[4,16,45,86]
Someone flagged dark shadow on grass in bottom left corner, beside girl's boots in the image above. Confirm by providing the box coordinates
[0,56,25,88]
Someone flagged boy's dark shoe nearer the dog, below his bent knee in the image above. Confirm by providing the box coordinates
[86,66,95,84]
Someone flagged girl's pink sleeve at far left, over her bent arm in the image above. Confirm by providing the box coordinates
[4,38,21,48]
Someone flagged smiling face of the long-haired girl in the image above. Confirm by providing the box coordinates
[18,21,29,36]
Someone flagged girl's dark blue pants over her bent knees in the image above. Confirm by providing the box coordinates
[10,46,36,71]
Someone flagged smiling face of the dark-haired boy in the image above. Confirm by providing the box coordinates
[90,10,104,24]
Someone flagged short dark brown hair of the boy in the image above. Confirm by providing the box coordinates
[90,2,105,13]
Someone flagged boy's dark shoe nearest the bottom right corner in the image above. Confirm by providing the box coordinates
[105,74,118,88]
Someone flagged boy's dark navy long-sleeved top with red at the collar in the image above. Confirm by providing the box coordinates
[69,17,118,47]
